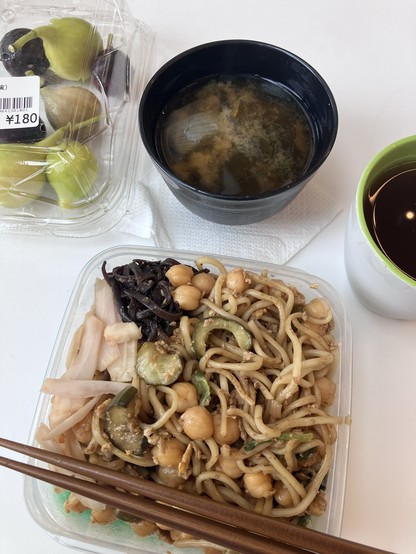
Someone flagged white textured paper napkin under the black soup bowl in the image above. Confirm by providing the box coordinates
[117,158,341,264]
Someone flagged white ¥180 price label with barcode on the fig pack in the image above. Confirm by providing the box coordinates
[0,75,40,129]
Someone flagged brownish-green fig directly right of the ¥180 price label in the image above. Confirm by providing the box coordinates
[40,85,101,142]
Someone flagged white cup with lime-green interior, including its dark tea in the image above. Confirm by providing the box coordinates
[344,135,416,321]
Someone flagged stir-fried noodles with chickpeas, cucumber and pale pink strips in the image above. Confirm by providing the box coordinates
[37,257,341,546]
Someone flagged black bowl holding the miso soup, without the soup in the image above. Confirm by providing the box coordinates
[139,40,338,225]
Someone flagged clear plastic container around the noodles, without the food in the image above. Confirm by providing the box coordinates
[25,246,352,554]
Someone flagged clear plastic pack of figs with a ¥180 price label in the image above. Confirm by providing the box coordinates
[0,0,153,237]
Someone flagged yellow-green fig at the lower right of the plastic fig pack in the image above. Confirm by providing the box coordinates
[46,140,98,209]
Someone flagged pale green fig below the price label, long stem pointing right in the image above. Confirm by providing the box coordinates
[0,113,100,208]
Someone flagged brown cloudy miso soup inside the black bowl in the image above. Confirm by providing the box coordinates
[158,77,314,196]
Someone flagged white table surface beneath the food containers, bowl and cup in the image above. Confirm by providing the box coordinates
[0,0,416,554]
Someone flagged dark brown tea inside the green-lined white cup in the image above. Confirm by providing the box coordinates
[364,163,416,279]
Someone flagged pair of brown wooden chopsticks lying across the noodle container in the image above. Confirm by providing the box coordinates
[0,437,394,554]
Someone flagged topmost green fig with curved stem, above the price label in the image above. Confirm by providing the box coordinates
[9,17,103,81]
